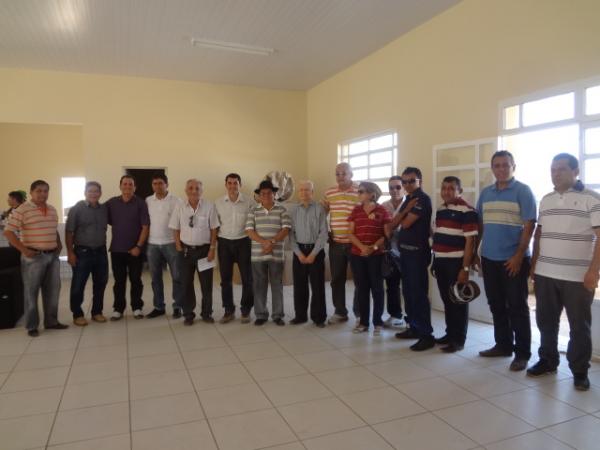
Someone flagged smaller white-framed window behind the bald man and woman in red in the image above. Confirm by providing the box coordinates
[338,131,398,202]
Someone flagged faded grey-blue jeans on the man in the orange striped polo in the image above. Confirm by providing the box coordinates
[21,253,60,330]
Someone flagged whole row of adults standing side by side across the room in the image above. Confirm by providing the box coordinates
[5,150,600,390]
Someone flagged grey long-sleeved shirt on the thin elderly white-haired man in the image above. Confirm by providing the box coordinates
[290,201,327,256]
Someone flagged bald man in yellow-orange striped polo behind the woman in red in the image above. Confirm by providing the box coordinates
[323,163,360,324]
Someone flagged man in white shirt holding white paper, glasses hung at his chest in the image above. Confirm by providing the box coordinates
[169,178,220,325]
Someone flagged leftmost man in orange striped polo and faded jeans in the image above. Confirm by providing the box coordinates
[4,180,68,337]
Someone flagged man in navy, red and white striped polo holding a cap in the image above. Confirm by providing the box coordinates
[432,176,479,353]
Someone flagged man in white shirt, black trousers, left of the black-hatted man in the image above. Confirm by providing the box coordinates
[215,173,254,323]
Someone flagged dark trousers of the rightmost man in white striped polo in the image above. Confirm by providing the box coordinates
[534,275,594,374]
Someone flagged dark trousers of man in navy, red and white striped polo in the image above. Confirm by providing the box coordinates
[433,258,469,345]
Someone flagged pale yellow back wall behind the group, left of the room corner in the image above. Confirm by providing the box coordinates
[0,69,306,202]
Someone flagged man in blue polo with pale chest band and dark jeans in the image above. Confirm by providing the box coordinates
[477,150,536,371]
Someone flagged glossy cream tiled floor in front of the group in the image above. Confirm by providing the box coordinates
[0,279,600,450]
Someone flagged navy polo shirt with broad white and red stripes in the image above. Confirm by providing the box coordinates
[432,197,479,258]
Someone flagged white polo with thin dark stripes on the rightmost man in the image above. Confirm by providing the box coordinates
[535,183,600,283]
